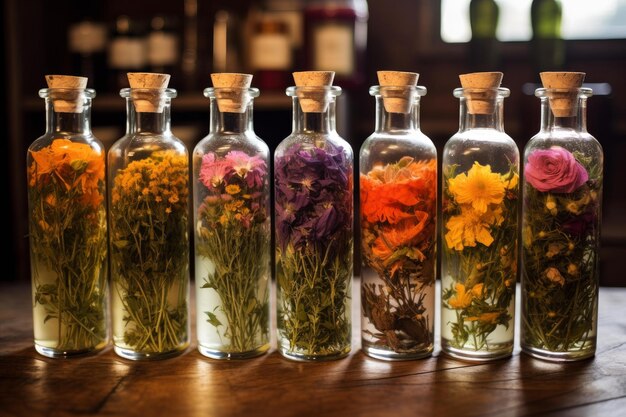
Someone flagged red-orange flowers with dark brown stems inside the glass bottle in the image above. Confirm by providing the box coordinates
[360,157,437,352]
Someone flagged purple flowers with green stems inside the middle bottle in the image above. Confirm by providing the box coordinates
[274,141,353,356]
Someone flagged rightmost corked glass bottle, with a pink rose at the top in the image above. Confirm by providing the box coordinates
[521,72,603,361]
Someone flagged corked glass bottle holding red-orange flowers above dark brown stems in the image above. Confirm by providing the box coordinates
[359,71,437,360]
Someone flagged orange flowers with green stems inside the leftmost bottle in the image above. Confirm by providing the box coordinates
[28,138,107,352]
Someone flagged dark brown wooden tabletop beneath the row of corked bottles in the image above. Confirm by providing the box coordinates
[0,282,626,417]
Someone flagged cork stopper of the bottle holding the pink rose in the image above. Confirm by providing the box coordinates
[539,72,585,117]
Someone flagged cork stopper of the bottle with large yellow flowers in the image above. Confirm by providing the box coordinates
[459,72,503,114]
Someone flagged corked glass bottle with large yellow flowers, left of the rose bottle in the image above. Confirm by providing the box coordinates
[441,72,519,361]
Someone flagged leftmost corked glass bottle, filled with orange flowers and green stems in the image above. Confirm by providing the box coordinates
[27,75,109,357]
